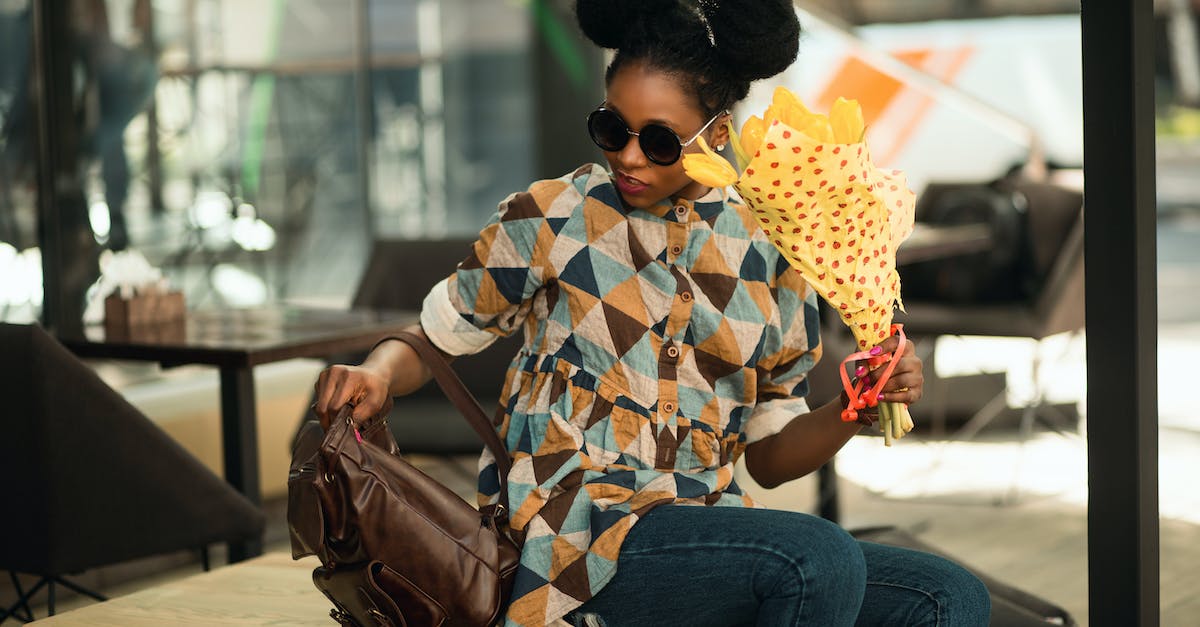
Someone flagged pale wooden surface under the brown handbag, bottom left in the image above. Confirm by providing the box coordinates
[36,553,334,627]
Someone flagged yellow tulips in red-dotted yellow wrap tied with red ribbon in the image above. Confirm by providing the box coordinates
[683,86,916,446]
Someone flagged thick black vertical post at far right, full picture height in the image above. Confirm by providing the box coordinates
[1082,0,1159,626]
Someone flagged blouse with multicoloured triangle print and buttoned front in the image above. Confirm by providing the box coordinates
[421,165,820,626]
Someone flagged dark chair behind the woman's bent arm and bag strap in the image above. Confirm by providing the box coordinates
[298,238,522,455]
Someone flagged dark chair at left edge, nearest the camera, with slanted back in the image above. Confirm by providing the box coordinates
[0,324,265,622]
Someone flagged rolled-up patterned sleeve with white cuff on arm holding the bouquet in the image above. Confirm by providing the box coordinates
[745,252,821,443]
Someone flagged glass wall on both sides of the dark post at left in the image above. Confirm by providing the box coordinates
[0,0,534,321]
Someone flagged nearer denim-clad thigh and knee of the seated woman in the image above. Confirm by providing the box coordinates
[568,506,866,627]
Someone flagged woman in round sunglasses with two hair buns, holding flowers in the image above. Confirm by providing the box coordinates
[317,0,989,626]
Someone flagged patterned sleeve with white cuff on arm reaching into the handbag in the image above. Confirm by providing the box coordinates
[421,187,553,354]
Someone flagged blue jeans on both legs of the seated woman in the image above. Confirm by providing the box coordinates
[566,506,991,627]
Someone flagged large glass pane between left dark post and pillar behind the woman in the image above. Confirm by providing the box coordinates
[70,0,533,306]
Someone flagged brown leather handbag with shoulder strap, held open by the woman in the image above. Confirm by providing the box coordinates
[288,333,521,627]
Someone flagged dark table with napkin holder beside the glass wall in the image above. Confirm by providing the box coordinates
[59,305,418,562]
